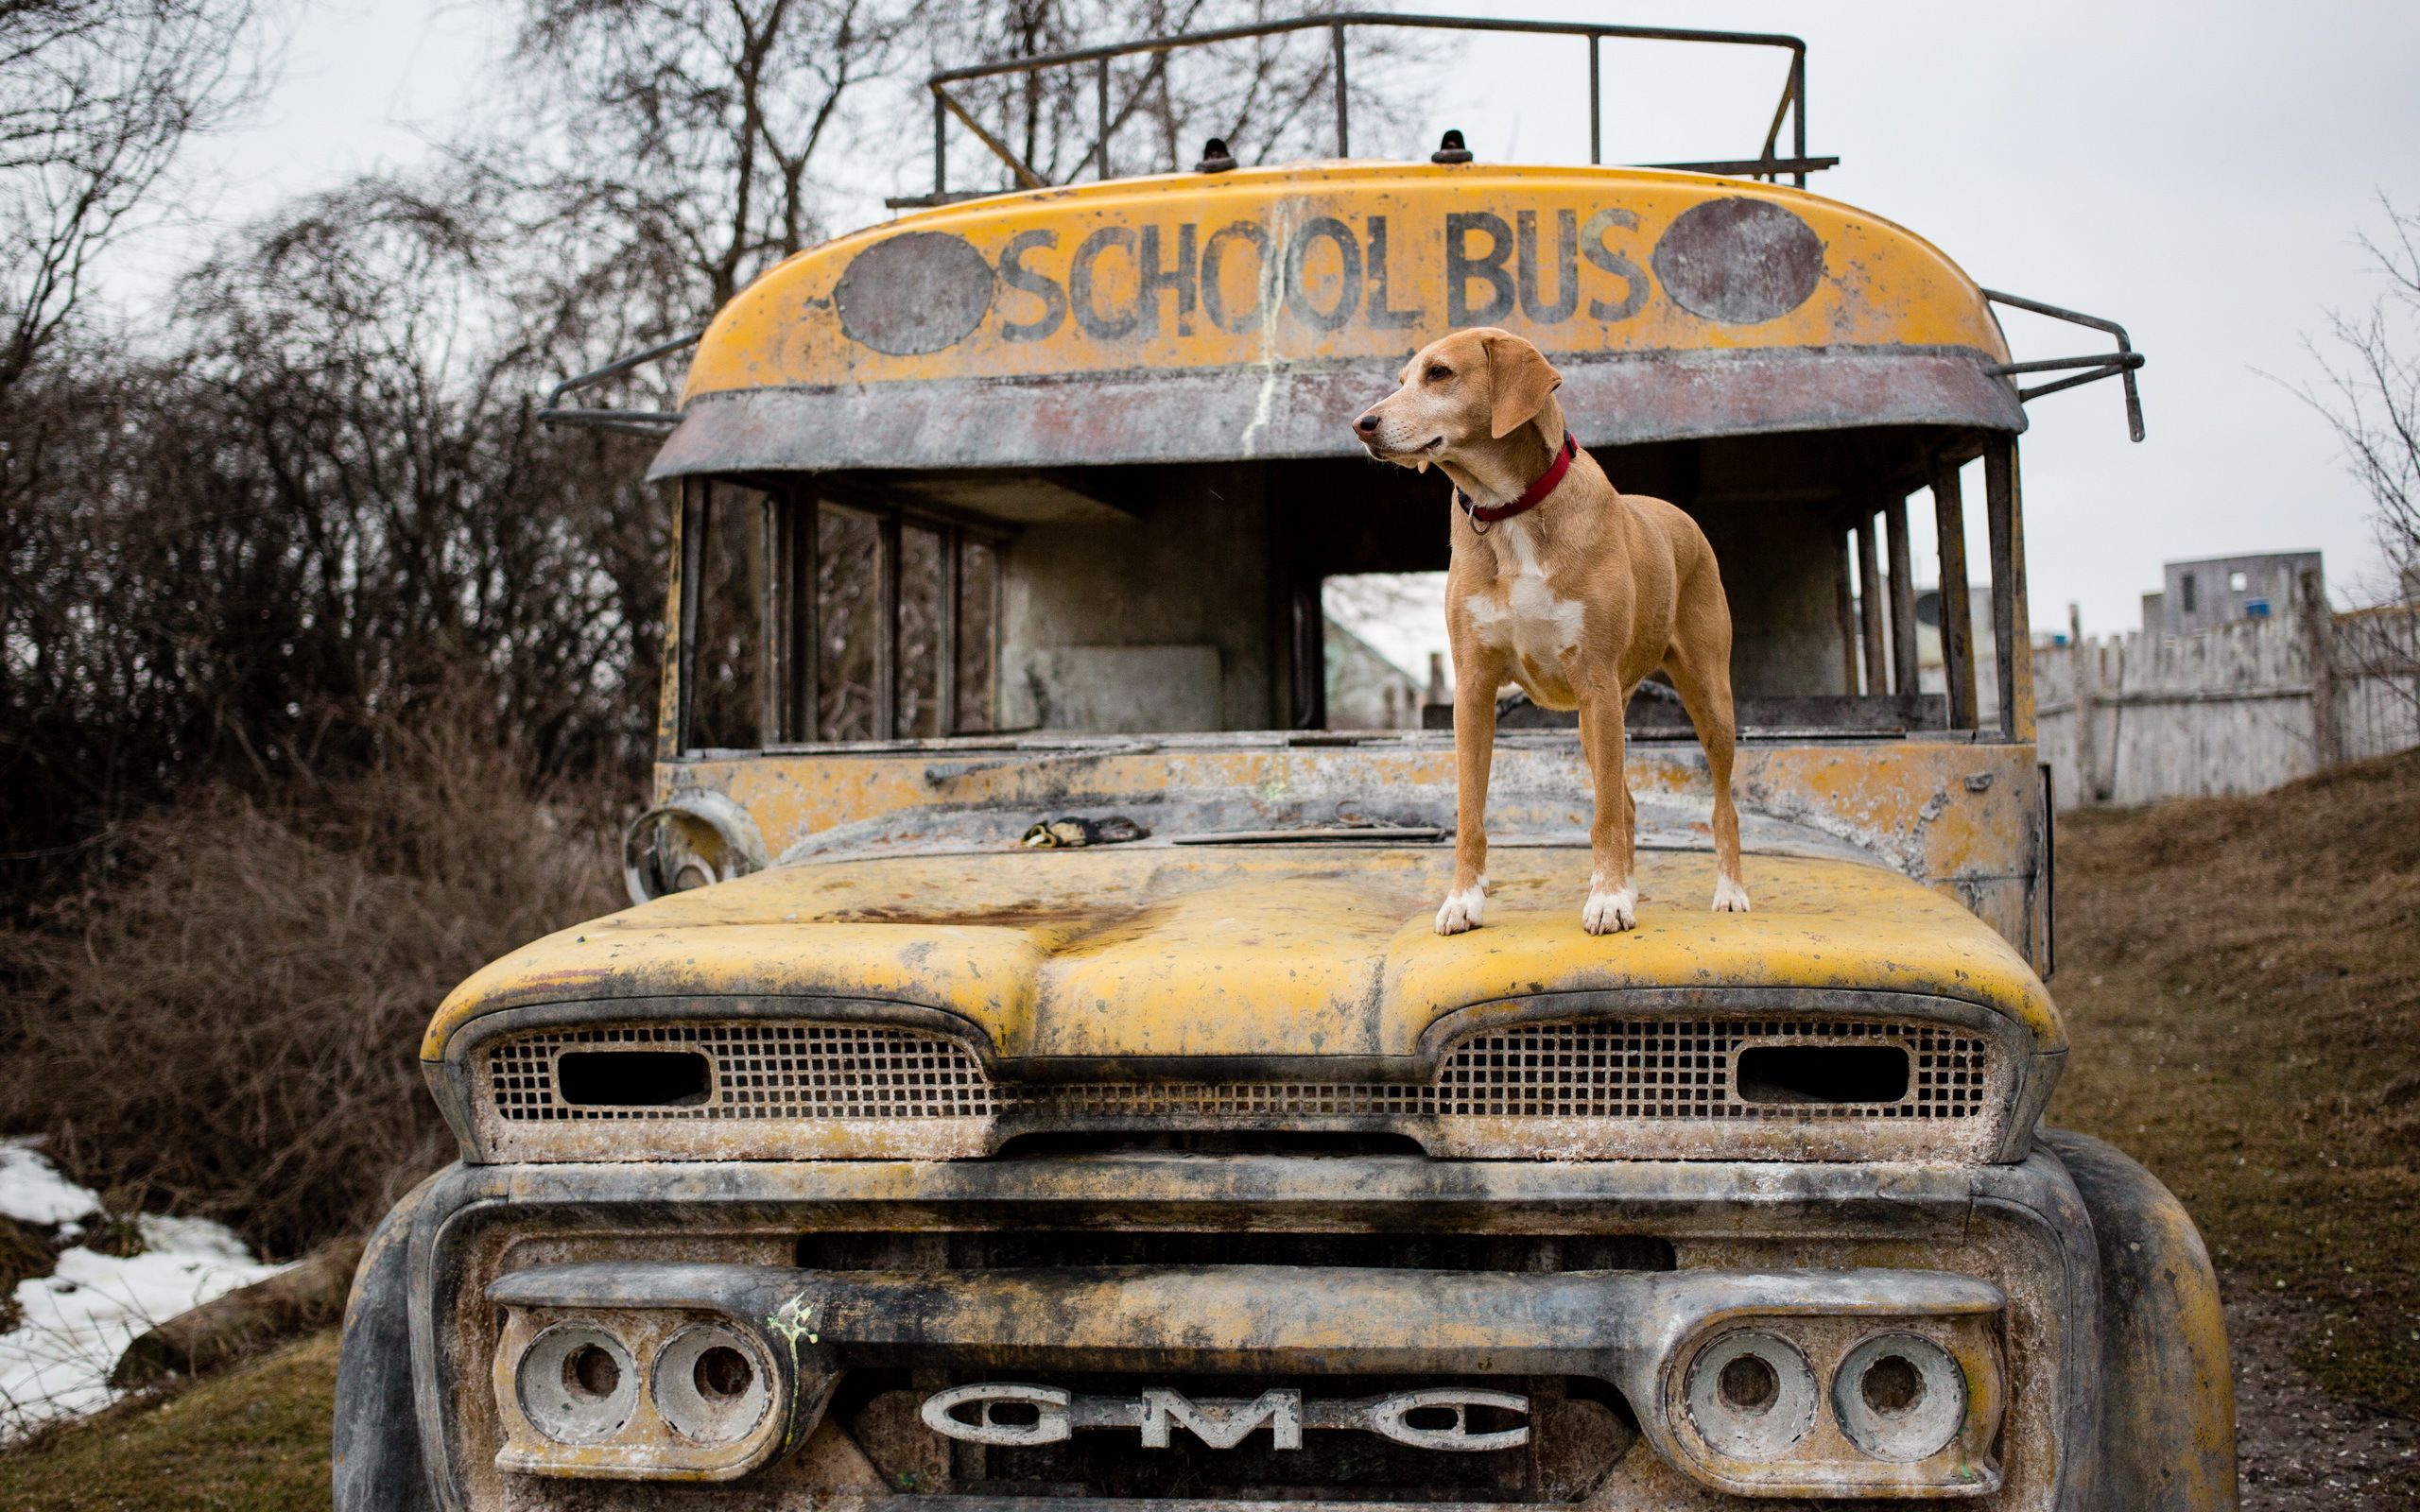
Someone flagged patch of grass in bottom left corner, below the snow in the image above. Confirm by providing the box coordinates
[0,1331,337,1512]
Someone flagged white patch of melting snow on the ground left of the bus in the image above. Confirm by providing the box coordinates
[0,1142,285,1444]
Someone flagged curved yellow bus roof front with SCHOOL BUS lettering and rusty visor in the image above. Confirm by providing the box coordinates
[653,163,2026,476]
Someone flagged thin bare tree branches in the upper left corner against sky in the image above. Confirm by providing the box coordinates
[0,0,267,392]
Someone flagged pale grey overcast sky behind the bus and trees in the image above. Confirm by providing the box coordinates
[183,0,2420,634]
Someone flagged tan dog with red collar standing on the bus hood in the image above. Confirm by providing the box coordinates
[1353,327,1747,934]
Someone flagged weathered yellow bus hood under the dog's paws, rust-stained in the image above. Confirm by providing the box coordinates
[421,847,2066,1074]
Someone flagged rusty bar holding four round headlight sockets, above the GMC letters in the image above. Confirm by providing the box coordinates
[487,1263,2006,1495]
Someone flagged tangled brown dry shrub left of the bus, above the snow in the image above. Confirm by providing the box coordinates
[0,718,622,1256]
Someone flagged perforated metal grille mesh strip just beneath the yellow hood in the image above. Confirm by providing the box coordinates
[489,1019,1989,1123]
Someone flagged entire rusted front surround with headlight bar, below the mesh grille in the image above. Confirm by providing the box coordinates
[363,1154,2100,1512]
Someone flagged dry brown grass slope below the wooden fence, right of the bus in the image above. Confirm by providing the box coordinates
[2049,752,2420,1416]
